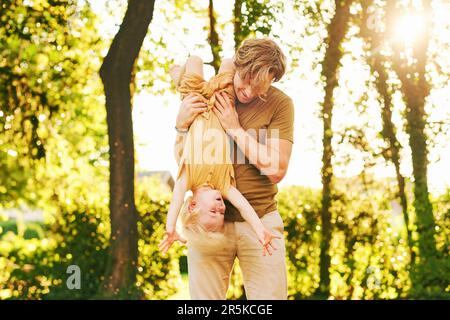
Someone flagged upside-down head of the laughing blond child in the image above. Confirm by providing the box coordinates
[181,186,229,248]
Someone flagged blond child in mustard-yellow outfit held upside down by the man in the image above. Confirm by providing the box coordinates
[159,57,279,255]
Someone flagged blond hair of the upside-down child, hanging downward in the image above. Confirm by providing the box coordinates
[180,196,226,252]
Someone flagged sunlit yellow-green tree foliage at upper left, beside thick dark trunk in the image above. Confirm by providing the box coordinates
[0,0,98,207]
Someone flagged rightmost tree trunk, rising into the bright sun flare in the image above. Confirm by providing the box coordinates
[386,0,437,265]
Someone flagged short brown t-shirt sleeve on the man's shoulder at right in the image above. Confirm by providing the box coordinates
[267,97,294,143]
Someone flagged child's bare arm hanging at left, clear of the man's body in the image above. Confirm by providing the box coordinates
[159,169,187,253]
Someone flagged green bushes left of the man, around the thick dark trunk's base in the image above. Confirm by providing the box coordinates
[0,179,181,299]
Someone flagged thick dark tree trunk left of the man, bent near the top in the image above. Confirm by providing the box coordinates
[100,0,154,296]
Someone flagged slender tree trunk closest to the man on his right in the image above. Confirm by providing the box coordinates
[317,0,352,298]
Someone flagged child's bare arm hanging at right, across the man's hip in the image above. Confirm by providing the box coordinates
[226,186,281,255]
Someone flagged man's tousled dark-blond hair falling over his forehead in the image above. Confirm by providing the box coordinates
[234,38,286,89]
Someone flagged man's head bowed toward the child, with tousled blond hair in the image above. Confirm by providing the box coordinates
[234,38,286,103]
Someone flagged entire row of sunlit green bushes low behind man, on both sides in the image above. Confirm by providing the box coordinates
[0,179,450,299]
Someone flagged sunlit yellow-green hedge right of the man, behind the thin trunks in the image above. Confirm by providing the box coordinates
[228,184,450,299]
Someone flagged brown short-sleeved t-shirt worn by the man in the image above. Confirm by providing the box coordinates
[225,86,294,221]
